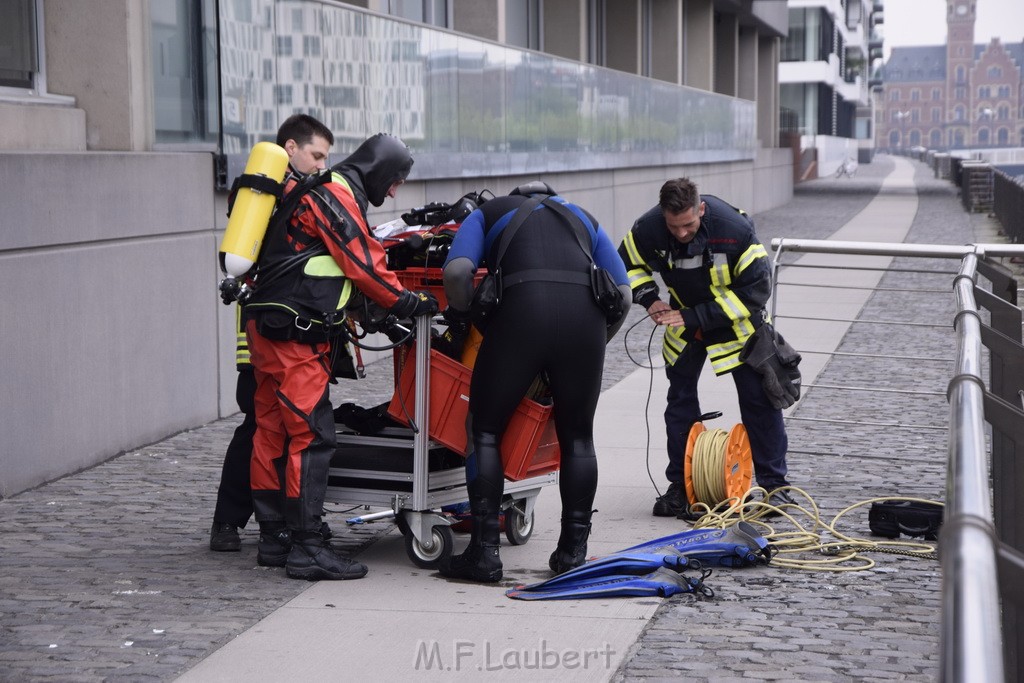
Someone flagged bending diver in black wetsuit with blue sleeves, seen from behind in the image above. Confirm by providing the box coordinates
[440,181,632,582]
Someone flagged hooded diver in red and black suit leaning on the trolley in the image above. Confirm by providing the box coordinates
[244,133,437,581]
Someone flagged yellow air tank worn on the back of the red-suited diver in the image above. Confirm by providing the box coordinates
[220,142,288,278]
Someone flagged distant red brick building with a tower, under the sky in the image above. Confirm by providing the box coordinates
[876,0,1024,150]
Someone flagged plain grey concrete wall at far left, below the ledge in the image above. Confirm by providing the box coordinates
[0,153,220,498]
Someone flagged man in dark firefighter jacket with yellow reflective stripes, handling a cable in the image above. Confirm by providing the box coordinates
[618,178,788,518]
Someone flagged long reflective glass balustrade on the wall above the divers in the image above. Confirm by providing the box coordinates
[152,0,758,187]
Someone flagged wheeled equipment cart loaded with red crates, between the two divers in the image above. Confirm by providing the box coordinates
[327,315,558,569]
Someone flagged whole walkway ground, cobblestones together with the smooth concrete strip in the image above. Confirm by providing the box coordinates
[0,157,998,682]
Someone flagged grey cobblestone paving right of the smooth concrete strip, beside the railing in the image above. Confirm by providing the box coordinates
[616,157,991,682]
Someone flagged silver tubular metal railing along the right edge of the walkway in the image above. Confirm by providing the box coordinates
[772,239,1024,683]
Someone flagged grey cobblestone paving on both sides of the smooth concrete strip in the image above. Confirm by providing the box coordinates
[0,157,1007,683]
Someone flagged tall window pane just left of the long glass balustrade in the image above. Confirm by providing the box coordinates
[150,0,220,146]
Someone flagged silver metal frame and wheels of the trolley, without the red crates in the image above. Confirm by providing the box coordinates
[326,315,558,569]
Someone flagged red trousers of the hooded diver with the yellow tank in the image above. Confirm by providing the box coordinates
[246,321,337,531]
